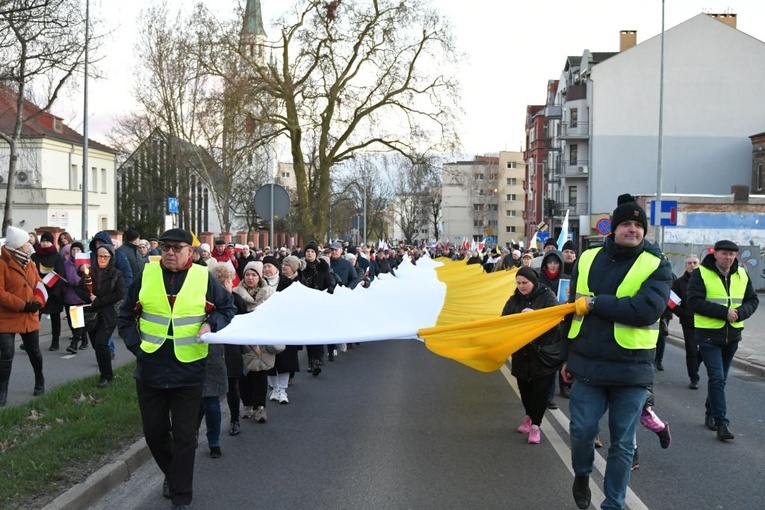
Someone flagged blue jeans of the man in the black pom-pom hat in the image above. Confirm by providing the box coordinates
[569,379,647,510]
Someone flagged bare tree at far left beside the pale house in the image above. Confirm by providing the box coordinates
[0,0,85,235]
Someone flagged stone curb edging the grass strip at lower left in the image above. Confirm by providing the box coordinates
[43,438,151,510]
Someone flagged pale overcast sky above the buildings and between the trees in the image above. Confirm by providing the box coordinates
[54,0,765,154]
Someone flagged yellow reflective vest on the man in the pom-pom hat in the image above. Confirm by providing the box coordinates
[568,247,661,349]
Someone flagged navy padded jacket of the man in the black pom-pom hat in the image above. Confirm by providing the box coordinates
[561,234,672,386]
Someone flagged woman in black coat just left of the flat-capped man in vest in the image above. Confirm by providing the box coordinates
[78,244,125,388]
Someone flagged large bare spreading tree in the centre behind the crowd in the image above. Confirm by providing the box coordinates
[236,0,458,239]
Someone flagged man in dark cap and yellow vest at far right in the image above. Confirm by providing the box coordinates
[686,240,759,441]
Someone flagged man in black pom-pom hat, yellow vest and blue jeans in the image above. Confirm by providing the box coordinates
[561,194,672,508]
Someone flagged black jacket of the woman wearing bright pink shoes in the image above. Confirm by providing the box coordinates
[502,284,563,381]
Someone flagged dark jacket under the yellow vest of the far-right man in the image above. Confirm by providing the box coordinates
[687,253,760,345]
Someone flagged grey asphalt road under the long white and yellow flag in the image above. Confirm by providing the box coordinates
[90,341,765,510]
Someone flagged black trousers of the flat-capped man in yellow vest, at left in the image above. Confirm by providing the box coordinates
[136,380,202,505]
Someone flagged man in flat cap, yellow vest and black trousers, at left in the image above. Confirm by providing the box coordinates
[118,228,236,509]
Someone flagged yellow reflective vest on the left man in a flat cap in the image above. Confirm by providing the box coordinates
[138,264,209,363]
